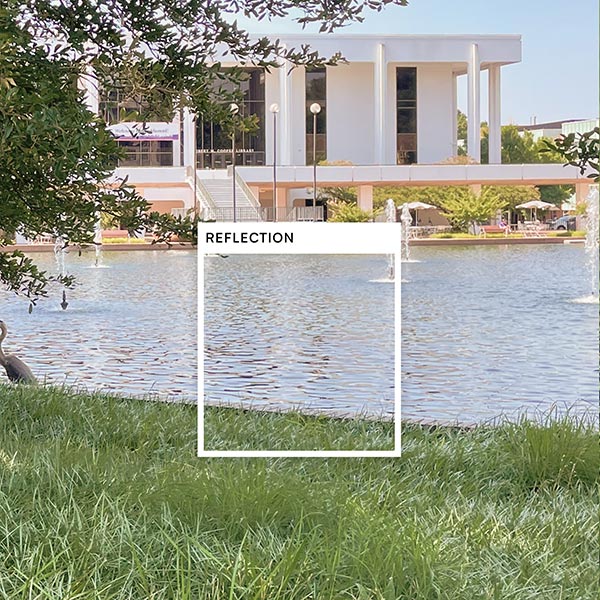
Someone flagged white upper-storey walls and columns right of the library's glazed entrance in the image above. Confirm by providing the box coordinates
[220,35,521,165]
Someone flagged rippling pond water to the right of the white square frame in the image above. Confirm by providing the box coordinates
[402,245,598,422]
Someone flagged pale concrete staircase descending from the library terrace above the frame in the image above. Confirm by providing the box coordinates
[197,171,262,221]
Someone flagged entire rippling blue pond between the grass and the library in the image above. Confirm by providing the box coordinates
[0,245,598,423]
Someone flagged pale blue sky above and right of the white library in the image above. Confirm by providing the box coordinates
[238,0,599,125]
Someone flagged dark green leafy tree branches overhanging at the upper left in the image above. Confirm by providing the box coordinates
[0,0,407,304]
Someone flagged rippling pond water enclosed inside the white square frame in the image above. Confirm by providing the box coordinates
[205,255,394,414]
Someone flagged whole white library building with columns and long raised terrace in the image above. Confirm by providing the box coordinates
[83,34,585,220]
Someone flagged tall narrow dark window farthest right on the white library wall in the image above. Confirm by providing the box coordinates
[396,67,417,165]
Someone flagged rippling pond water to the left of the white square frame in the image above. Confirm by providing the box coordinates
[0,250,197,400]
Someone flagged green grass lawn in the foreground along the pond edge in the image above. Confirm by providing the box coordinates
[0,386,599,600]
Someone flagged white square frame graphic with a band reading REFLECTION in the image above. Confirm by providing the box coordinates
[197,222,402,458]
